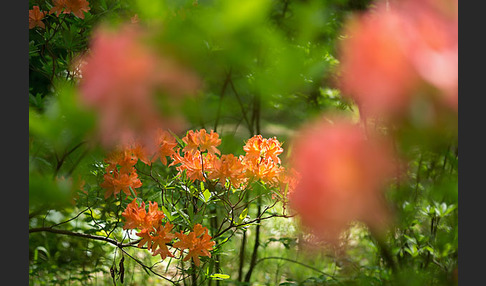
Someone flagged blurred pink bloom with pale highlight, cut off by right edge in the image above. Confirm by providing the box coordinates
[400,0,459,111]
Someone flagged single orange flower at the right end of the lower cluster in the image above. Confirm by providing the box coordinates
[174,224,216,266]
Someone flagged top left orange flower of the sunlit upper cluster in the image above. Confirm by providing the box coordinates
[182,129,221,154]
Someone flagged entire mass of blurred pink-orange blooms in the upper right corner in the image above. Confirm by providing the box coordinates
[340,0,458,118]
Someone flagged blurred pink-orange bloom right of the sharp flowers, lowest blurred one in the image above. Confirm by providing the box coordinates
[289,117,395,244]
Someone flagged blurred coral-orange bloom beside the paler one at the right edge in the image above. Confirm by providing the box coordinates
[340,9,417,117]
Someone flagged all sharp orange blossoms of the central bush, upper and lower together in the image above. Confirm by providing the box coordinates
[101,129,297,266]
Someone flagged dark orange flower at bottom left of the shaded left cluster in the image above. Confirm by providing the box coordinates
[100,168,142,198]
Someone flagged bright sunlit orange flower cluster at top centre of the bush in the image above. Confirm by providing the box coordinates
[169,129,290,196]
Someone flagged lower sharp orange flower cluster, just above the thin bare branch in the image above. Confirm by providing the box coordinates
[122,199,215,266]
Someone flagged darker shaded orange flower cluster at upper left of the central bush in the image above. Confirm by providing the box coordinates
[101,129,177,198]
